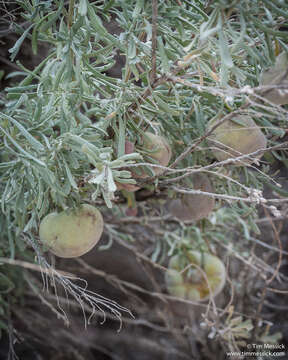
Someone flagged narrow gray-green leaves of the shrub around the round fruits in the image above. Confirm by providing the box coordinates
[0,0,288,344]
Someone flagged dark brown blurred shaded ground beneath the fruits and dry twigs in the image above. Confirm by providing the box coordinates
[0,194,288,360]
